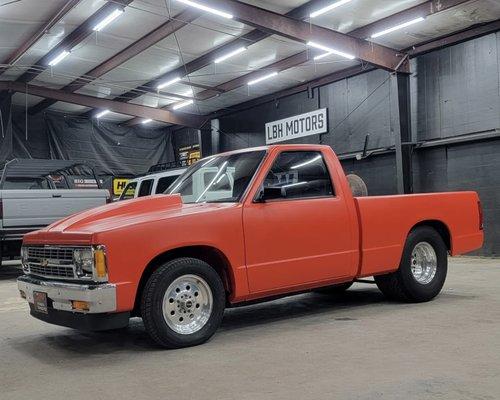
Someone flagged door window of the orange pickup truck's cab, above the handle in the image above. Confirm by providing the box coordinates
[264,151,335,199]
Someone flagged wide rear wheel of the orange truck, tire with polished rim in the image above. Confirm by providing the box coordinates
[375,226,448,303]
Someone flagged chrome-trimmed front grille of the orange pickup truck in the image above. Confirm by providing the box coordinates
[25,246,87,279]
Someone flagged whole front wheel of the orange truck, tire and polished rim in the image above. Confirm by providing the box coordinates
[141,258,226,349]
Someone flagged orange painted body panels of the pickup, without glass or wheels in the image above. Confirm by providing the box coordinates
[24,145,483,311]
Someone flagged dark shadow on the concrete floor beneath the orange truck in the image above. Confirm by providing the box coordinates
[8,286,468,364]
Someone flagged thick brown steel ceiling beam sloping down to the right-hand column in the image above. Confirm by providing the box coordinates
[196,0,409,72]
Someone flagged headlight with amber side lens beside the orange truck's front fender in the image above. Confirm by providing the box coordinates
[73,246,108,282]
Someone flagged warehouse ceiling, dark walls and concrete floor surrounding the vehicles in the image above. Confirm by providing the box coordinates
[0,0,500,399]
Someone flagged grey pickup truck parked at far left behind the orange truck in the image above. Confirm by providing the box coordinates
[0,159,110,262]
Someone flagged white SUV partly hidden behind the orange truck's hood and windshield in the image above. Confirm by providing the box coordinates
[118,168,186,200]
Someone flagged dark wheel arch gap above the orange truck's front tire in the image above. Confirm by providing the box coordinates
[133,245,235,315]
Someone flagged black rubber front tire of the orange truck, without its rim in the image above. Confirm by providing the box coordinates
[143,258,225,348]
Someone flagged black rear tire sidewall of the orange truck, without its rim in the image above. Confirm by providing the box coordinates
[398,227,448,302]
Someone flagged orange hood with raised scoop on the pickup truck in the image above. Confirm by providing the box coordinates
[27,195,227,240]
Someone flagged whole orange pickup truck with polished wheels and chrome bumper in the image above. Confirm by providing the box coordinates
[18,145,483,348]
